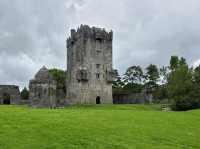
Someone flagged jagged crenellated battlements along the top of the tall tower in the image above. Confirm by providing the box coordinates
[67,25,113,47]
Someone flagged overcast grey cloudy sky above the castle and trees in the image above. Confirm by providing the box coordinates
[0,0,200,87]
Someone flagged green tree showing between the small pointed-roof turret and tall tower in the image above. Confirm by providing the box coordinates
[49,68,66,92]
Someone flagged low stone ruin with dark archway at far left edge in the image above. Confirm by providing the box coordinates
[0,85,20,104]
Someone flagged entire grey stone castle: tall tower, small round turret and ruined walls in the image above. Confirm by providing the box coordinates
[0,25,152,108]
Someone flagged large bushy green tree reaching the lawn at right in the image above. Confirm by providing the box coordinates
[168,59,198,110]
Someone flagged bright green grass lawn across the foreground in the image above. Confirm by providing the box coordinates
[0,105,200,149]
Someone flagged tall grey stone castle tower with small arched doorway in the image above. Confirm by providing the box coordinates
[67,25,115,104]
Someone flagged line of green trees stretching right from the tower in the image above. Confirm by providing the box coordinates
[113,56,200,110]
